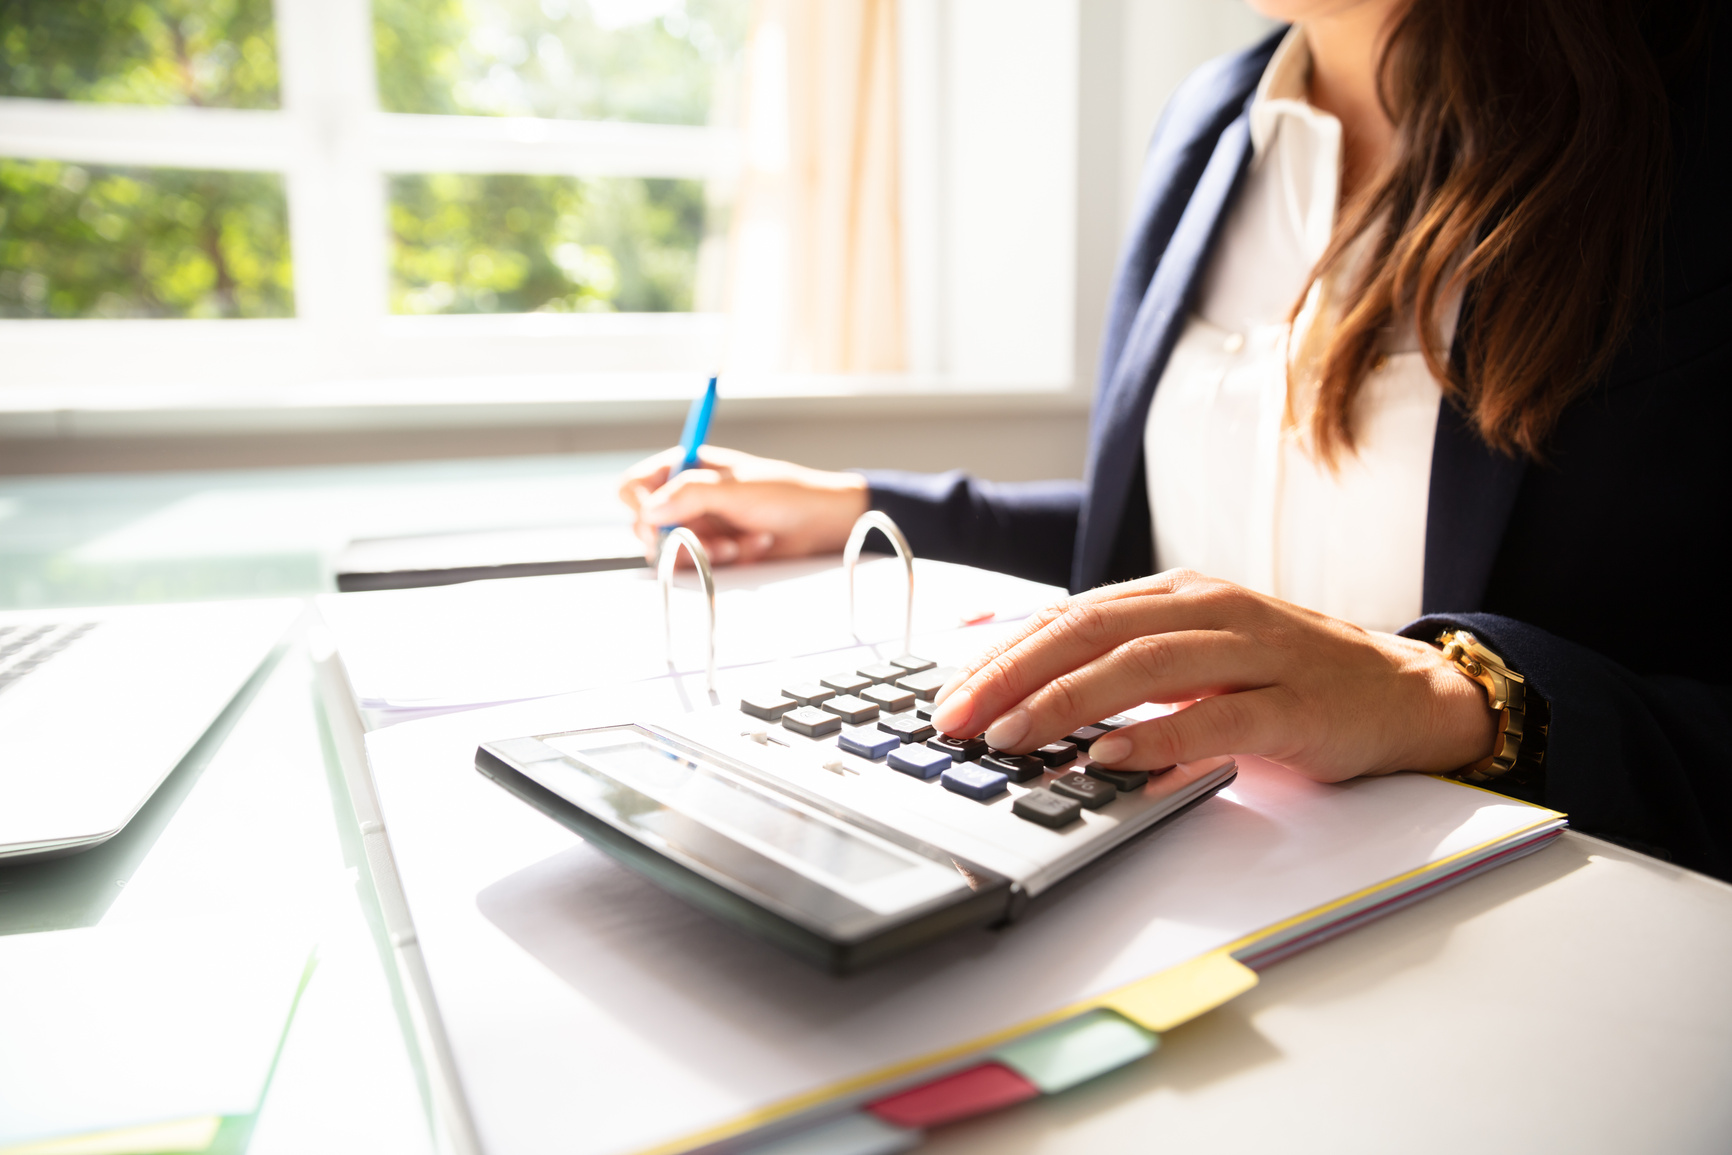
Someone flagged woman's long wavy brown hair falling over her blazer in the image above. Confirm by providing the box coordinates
[1294,0,1706,461]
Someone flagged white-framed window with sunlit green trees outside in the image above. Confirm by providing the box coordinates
[0,0,748,381]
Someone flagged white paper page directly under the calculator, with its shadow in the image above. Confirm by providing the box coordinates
[367,679,1550,1155]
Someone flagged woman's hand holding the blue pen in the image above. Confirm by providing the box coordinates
[620,445,866,565]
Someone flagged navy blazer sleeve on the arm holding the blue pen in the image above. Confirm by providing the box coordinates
[861,469,1083,585]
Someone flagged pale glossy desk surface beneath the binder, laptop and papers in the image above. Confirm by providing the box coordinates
[0,459,1732,1155]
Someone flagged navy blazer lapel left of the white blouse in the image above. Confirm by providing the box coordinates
[1070,109,1251,590]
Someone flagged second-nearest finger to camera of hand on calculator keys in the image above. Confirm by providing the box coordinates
[986,630,1275,753]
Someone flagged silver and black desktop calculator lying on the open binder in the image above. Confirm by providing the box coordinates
[476,651,1237,973]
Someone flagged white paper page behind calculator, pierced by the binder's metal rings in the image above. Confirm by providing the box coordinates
[319,558,1063,720]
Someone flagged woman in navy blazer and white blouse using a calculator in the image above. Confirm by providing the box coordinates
[622,0,1732,876]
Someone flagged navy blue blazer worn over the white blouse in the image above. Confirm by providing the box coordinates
[868,24,1732,878]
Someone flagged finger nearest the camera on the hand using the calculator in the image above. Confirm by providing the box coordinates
[1089,686,1302,771]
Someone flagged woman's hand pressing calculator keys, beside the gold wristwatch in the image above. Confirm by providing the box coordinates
[932,570,1495,781]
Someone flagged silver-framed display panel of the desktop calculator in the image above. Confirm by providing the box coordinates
[533,726,970,935]
